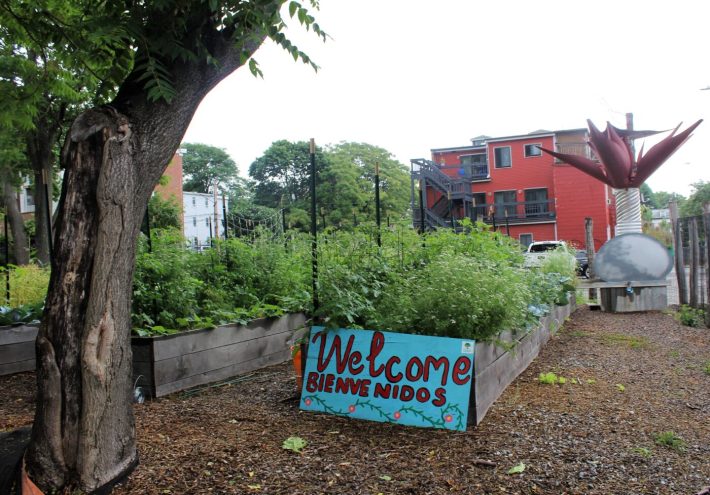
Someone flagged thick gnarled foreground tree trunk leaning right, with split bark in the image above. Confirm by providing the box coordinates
[25,28,263,492]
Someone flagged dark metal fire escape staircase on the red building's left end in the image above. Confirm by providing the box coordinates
[411,158,474,229]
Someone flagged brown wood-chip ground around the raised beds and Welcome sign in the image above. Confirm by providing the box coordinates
[0,307,710,495]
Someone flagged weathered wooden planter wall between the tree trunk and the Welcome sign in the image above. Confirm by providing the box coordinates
[131,313,306,397]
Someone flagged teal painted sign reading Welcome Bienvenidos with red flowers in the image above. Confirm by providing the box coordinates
[301,327,476,430]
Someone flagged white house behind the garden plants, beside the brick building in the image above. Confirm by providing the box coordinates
[182,191,229,249]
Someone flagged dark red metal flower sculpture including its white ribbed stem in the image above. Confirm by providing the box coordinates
[541,119,702,235]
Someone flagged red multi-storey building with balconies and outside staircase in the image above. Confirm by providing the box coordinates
[411,129,615,249]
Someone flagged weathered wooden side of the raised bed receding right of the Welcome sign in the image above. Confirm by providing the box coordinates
[469,297,575,424]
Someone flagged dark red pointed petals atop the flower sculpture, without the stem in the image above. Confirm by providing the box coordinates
[541,119,702,189]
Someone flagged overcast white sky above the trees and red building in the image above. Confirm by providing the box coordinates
[184,0,710,196]
